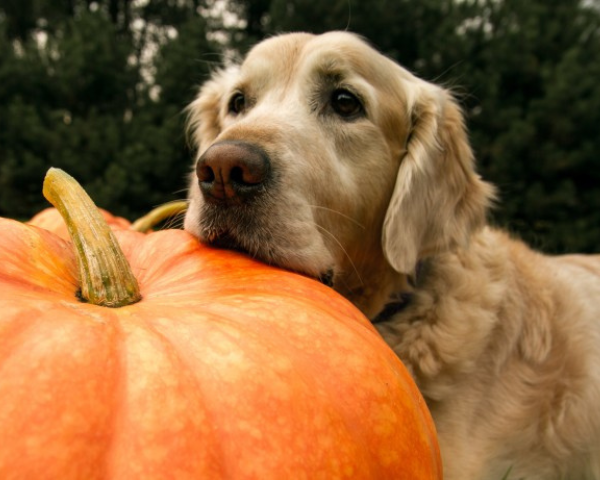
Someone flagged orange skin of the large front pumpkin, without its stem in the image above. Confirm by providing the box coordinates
[0,219,442,480]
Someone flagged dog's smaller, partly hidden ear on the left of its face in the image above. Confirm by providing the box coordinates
[186,66,239,152]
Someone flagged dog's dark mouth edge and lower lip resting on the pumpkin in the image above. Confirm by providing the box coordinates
[204,229,335,288]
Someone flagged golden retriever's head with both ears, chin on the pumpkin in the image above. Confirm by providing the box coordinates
[185,32,492,316]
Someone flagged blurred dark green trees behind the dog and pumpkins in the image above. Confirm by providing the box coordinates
[0,0,600,252]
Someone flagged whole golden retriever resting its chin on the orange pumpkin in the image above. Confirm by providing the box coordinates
[185,32,600,480]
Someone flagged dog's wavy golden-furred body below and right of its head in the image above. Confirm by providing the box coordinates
[377,228,600,480]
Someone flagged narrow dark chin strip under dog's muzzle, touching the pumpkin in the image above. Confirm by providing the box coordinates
[202,231,335,288]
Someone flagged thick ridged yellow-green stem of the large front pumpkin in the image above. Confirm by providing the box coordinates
[43,168,142,307]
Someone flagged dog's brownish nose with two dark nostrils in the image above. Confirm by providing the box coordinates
[196,141,271,203]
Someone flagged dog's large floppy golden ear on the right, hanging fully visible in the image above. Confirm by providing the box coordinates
[382,81,494,273]
